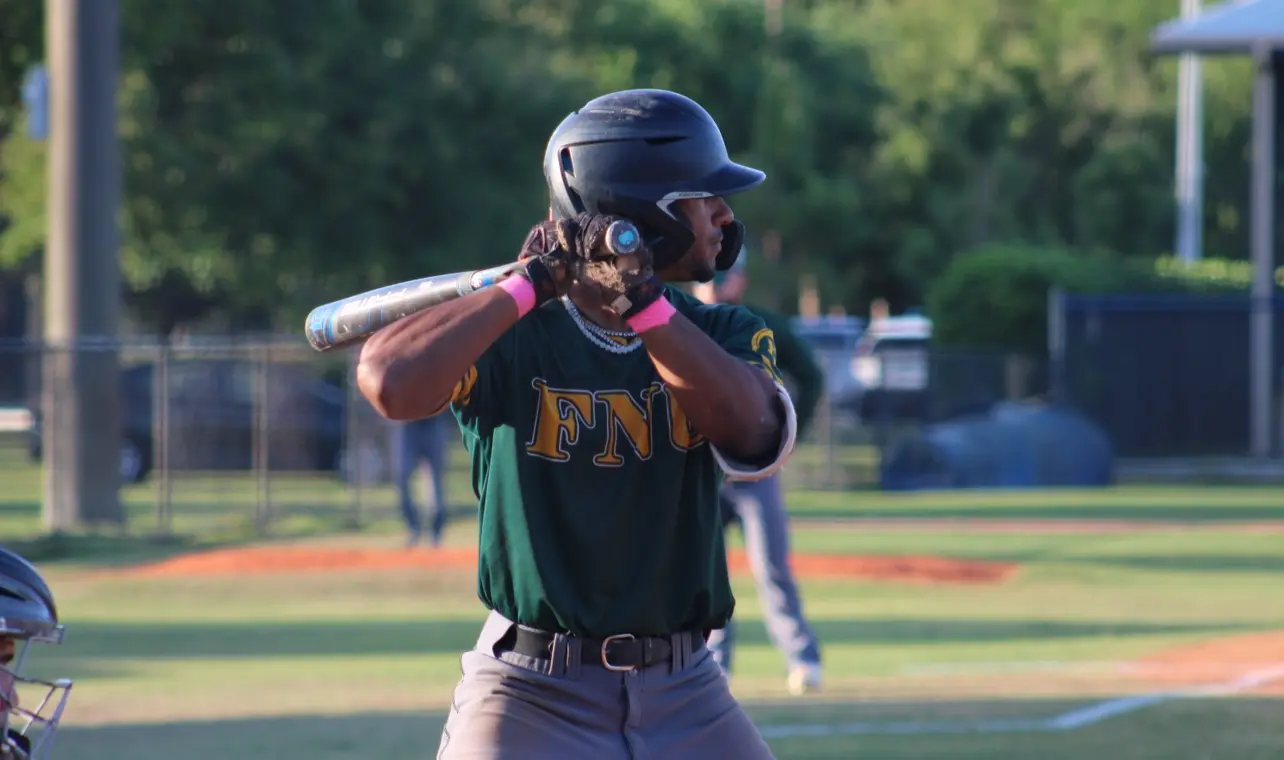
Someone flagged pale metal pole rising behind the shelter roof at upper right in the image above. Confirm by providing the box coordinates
[1176,0,1203,262]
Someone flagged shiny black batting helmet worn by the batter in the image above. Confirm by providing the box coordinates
[544,90,767,270]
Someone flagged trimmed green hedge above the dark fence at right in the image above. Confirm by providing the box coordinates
[924,245,1284,356]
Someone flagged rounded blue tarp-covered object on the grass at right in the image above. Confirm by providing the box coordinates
[881,402,1115,490]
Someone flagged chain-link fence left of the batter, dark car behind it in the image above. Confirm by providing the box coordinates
[0,338,436,533]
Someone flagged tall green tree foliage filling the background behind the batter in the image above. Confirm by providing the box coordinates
[0,0,1249,340]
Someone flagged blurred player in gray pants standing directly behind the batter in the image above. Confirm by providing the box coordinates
[692,249,824,695]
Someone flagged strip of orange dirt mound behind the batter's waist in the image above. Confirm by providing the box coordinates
[126,546,1018,584]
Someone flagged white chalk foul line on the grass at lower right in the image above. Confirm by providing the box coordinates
[758,665,1284,739]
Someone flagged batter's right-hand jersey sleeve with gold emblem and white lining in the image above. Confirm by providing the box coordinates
[710,307,797,480]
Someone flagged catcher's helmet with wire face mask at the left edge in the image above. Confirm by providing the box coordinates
[0,547,72,760]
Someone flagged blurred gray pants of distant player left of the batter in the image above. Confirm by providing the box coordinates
[392,412,458,543]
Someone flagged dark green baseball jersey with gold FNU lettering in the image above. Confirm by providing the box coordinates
[451,286,778,637]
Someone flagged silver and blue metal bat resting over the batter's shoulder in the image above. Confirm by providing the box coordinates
[304,220,642,350]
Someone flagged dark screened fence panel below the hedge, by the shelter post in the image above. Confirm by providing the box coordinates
[1053,293,1284,458]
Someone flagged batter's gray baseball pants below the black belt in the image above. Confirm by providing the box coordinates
[437,612,773,760]
